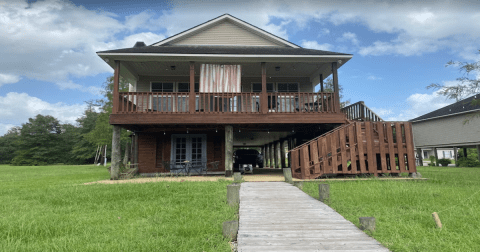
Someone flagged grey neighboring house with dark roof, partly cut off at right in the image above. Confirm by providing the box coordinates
[410,94,480,163]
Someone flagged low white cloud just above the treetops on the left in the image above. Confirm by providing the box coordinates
[0,92,87,136]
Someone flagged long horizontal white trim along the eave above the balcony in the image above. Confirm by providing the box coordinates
[97,53,353,59]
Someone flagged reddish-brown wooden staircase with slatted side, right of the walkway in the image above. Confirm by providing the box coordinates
[290,121,416,179]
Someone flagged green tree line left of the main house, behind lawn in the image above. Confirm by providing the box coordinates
[0,77,130,166]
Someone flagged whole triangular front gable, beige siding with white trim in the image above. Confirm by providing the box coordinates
[153,14,298,48]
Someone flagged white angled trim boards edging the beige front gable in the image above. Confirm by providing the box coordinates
[152,14,300,48]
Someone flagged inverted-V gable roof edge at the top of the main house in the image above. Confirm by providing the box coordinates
[151,14,301,48]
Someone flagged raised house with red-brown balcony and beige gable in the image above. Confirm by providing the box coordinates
[97,14,412,179]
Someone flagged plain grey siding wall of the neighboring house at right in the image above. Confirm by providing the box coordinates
[412,114,480,148]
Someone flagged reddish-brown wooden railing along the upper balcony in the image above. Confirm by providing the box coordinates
[117,92,339,113]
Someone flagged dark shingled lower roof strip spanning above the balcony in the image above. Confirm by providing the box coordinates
[97,46,352,58]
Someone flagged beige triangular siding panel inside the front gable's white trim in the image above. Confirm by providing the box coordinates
[172,21,284,46]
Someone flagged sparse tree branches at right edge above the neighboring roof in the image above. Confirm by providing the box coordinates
[427,50,480,105]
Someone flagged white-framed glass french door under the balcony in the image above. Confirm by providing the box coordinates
[171,134,207,172]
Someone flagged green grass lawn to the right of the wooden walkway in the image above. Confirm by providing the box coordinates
[303,167,480,252]
